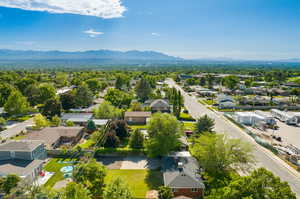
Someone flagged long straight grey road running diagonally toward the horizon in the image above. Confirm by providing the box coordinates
[167,80,300,198]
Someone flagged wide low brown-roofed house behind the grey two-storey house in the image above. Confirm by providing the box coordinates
[26,127,84,149]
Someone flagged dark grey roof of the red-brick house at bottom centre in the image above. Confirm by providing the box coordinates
[162,156,205,188]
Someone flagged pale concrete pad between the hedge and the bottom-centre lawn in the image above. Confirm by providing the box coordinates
[97,156,161,170]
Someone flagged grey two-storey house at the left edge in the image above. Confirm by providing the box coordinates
[0,140,47,182]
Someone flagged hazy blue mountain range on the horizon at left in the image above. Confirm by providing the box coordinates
[0,49,182,61]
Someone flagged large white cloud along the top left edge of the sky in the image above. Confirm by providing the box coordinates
[0,0,126,19]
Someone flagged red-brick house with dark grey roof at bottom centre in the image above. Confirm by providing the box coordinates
[162,152,205,198]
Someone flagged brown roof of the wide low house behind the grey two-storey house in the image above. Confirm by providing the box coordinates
[26,127,83,146]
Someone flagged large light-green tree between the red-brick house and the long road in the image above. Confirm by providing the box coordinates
[190,134,254,176]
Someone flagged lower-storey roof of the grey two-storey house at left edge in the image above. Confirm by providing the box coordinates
[0,159,43,177]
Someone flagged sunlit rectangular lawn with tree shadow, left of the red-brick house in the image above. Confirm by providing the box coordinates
[105,170,163,198]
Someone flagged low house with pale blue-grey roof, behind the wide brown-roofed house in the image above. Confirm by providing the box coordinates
[61,113,93,126]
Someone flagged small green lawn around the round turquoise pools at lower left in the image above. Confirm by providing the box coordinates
[44,158,76,187]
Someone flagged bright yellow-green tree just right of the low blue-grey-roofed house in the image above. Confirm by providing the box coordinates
[94,101,122,119]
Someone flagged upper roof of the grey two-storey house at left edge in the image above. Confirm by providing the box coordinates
[0,140,42,151]
